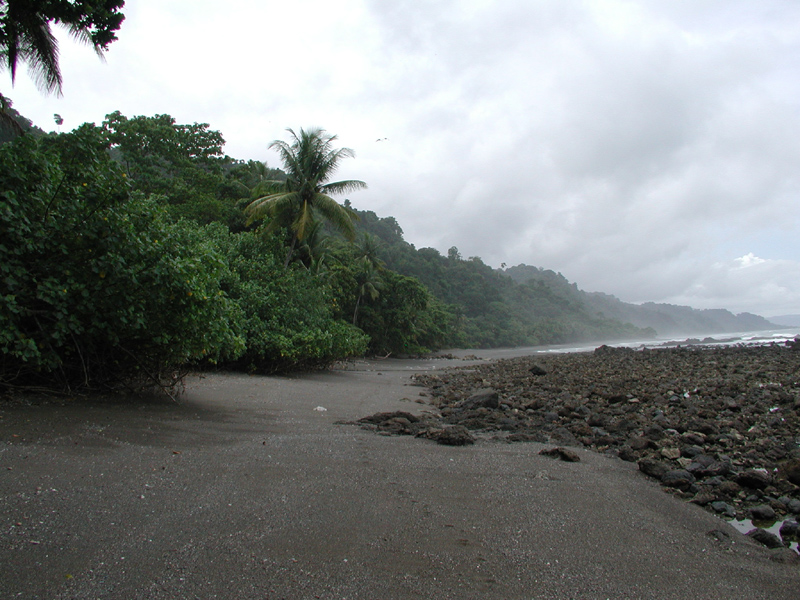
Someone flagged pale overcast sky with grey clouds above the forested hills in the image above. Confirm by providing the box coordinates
[2,0,800,316]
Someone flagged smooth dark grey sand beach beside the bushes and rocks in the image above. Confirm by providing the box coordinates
[0,359,800,600]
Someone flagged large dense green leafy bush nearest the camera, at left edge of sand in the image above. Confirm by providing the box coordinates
[0,125,243,389]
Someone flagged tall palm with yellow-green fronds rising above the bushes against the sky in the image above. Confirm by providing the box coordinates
[246,128,367,266]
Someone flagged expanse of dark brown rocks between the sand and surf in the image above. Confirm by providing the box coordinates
[360,342,800,545]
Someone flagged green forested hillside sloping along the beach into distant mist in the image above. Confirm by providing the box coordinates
[0,112,780,390]
